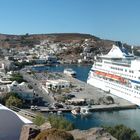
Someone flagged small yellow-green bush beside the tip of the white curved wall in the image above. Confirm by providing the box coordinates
[33,114,47,126]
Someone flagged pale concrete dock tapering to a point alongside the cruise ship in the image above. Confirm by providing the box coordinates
[65,76,136,108]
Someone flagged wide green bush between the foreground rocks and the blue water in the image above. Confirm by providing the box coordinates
[47,115,74,131]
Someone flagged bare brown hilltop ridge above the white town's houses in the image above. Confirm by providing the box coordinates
[0,33,114,47]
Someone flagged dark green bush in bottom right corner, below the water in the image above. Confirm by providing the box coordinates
[104,125,140,140]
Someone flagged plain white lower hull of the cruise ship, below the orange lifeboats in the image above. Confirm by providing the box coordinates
[87,77,140,106]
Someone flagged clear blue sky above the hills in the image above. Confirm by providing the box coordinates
[0,0,140,45]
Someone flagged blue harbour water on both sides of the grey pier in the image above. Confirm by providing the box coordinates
[35,65,140,134]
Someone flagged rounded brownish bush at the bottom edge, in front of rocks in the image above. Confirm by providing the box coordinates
[35,128,74,140]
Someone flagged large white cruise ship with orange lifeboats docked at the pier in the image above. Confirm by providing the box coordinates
[87,45,140,106]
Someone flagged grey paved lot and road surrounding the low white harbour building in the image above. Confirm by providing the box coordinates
[21,68,134,107]
